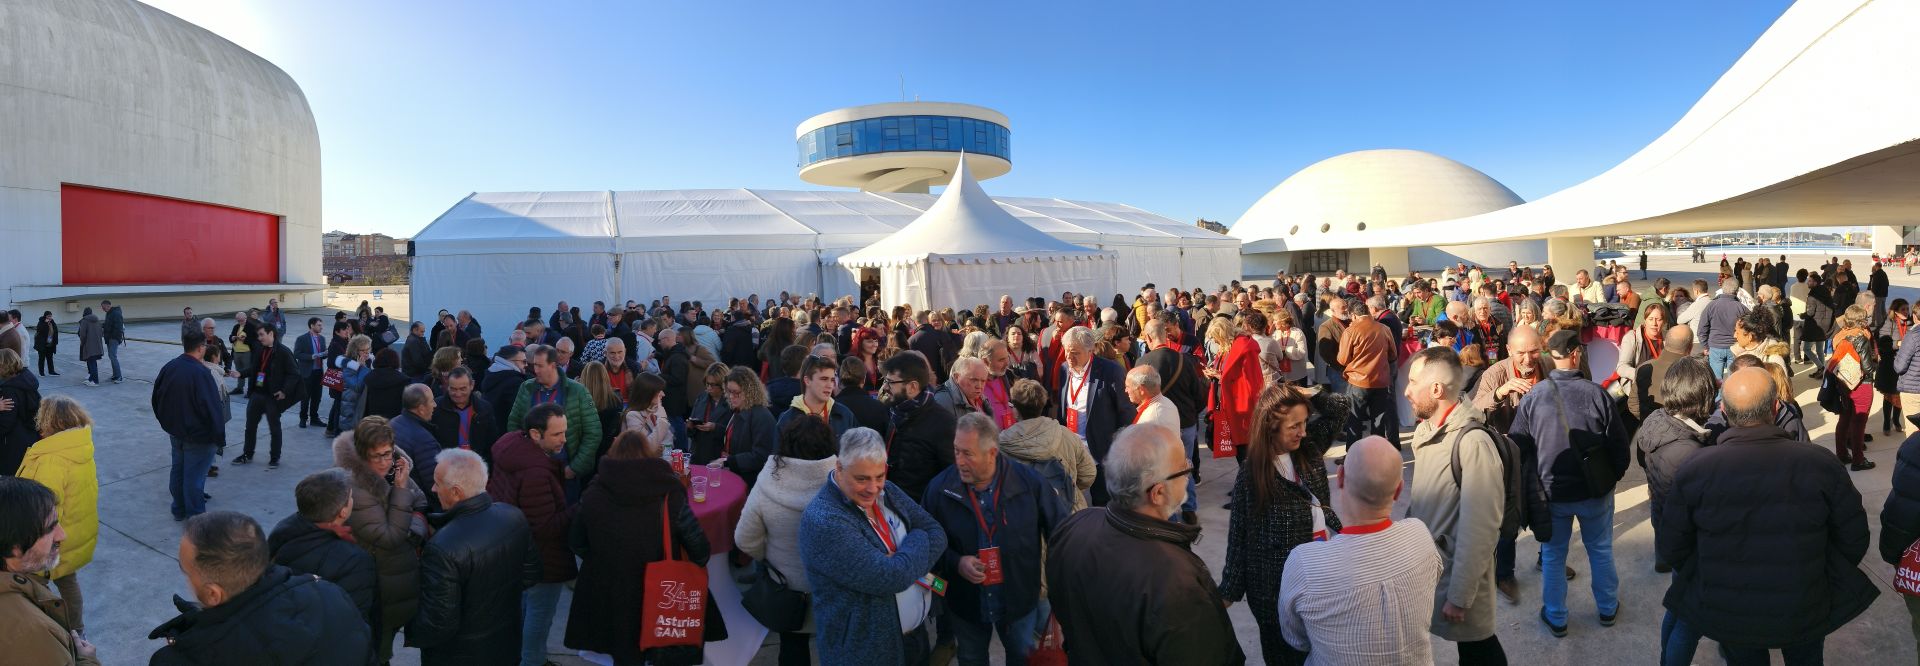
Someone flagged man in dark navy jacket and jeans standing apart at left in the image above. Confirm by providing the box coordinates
[152,330,227,520]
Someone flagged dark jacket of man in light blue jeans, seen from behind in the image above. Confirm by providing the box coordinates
[1507,369,1628,501]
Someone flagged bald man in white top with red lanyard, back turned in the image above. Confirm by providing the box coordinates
[1281,436,1440,664]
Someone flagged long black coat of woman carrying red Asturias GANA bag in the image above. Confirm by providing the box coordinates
[566,459,726,664]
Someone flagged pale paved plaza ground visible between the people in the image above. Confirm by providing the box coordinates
[44,257,1920,664]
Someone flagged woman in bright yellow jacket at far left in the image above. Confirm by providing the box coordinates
[17,395,100,631]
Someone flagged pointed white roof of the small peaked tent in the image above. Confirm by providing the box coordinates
[839,155,1114,267]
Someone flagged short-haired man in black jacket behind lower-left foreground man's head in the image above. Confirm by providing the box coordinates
[267,468,376,628]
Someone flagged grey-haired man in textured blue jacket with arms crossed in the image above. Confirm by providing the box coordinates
[801,428,947,666]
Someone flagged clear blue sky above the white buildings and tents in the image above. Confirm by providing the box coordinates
[148,0,1789,236]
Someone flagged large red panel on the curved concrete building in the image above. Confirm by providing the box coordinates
[60,184,280,284]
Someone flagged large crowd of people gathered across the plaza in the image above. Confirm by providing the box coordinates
[0,257,1920,666]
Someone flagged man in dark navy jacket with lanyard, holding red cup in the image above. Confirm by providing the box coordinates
[922,413,1068,664]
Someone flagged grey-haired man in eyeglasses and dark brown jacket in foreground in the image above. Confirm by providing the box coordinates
[1046,426,1246,664]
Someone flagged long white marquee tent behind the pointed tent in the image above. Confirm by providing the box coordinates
[413,182,1240,333]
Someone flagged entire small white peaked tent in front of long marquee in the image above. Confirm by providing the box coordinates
[839,159,1117,309]
